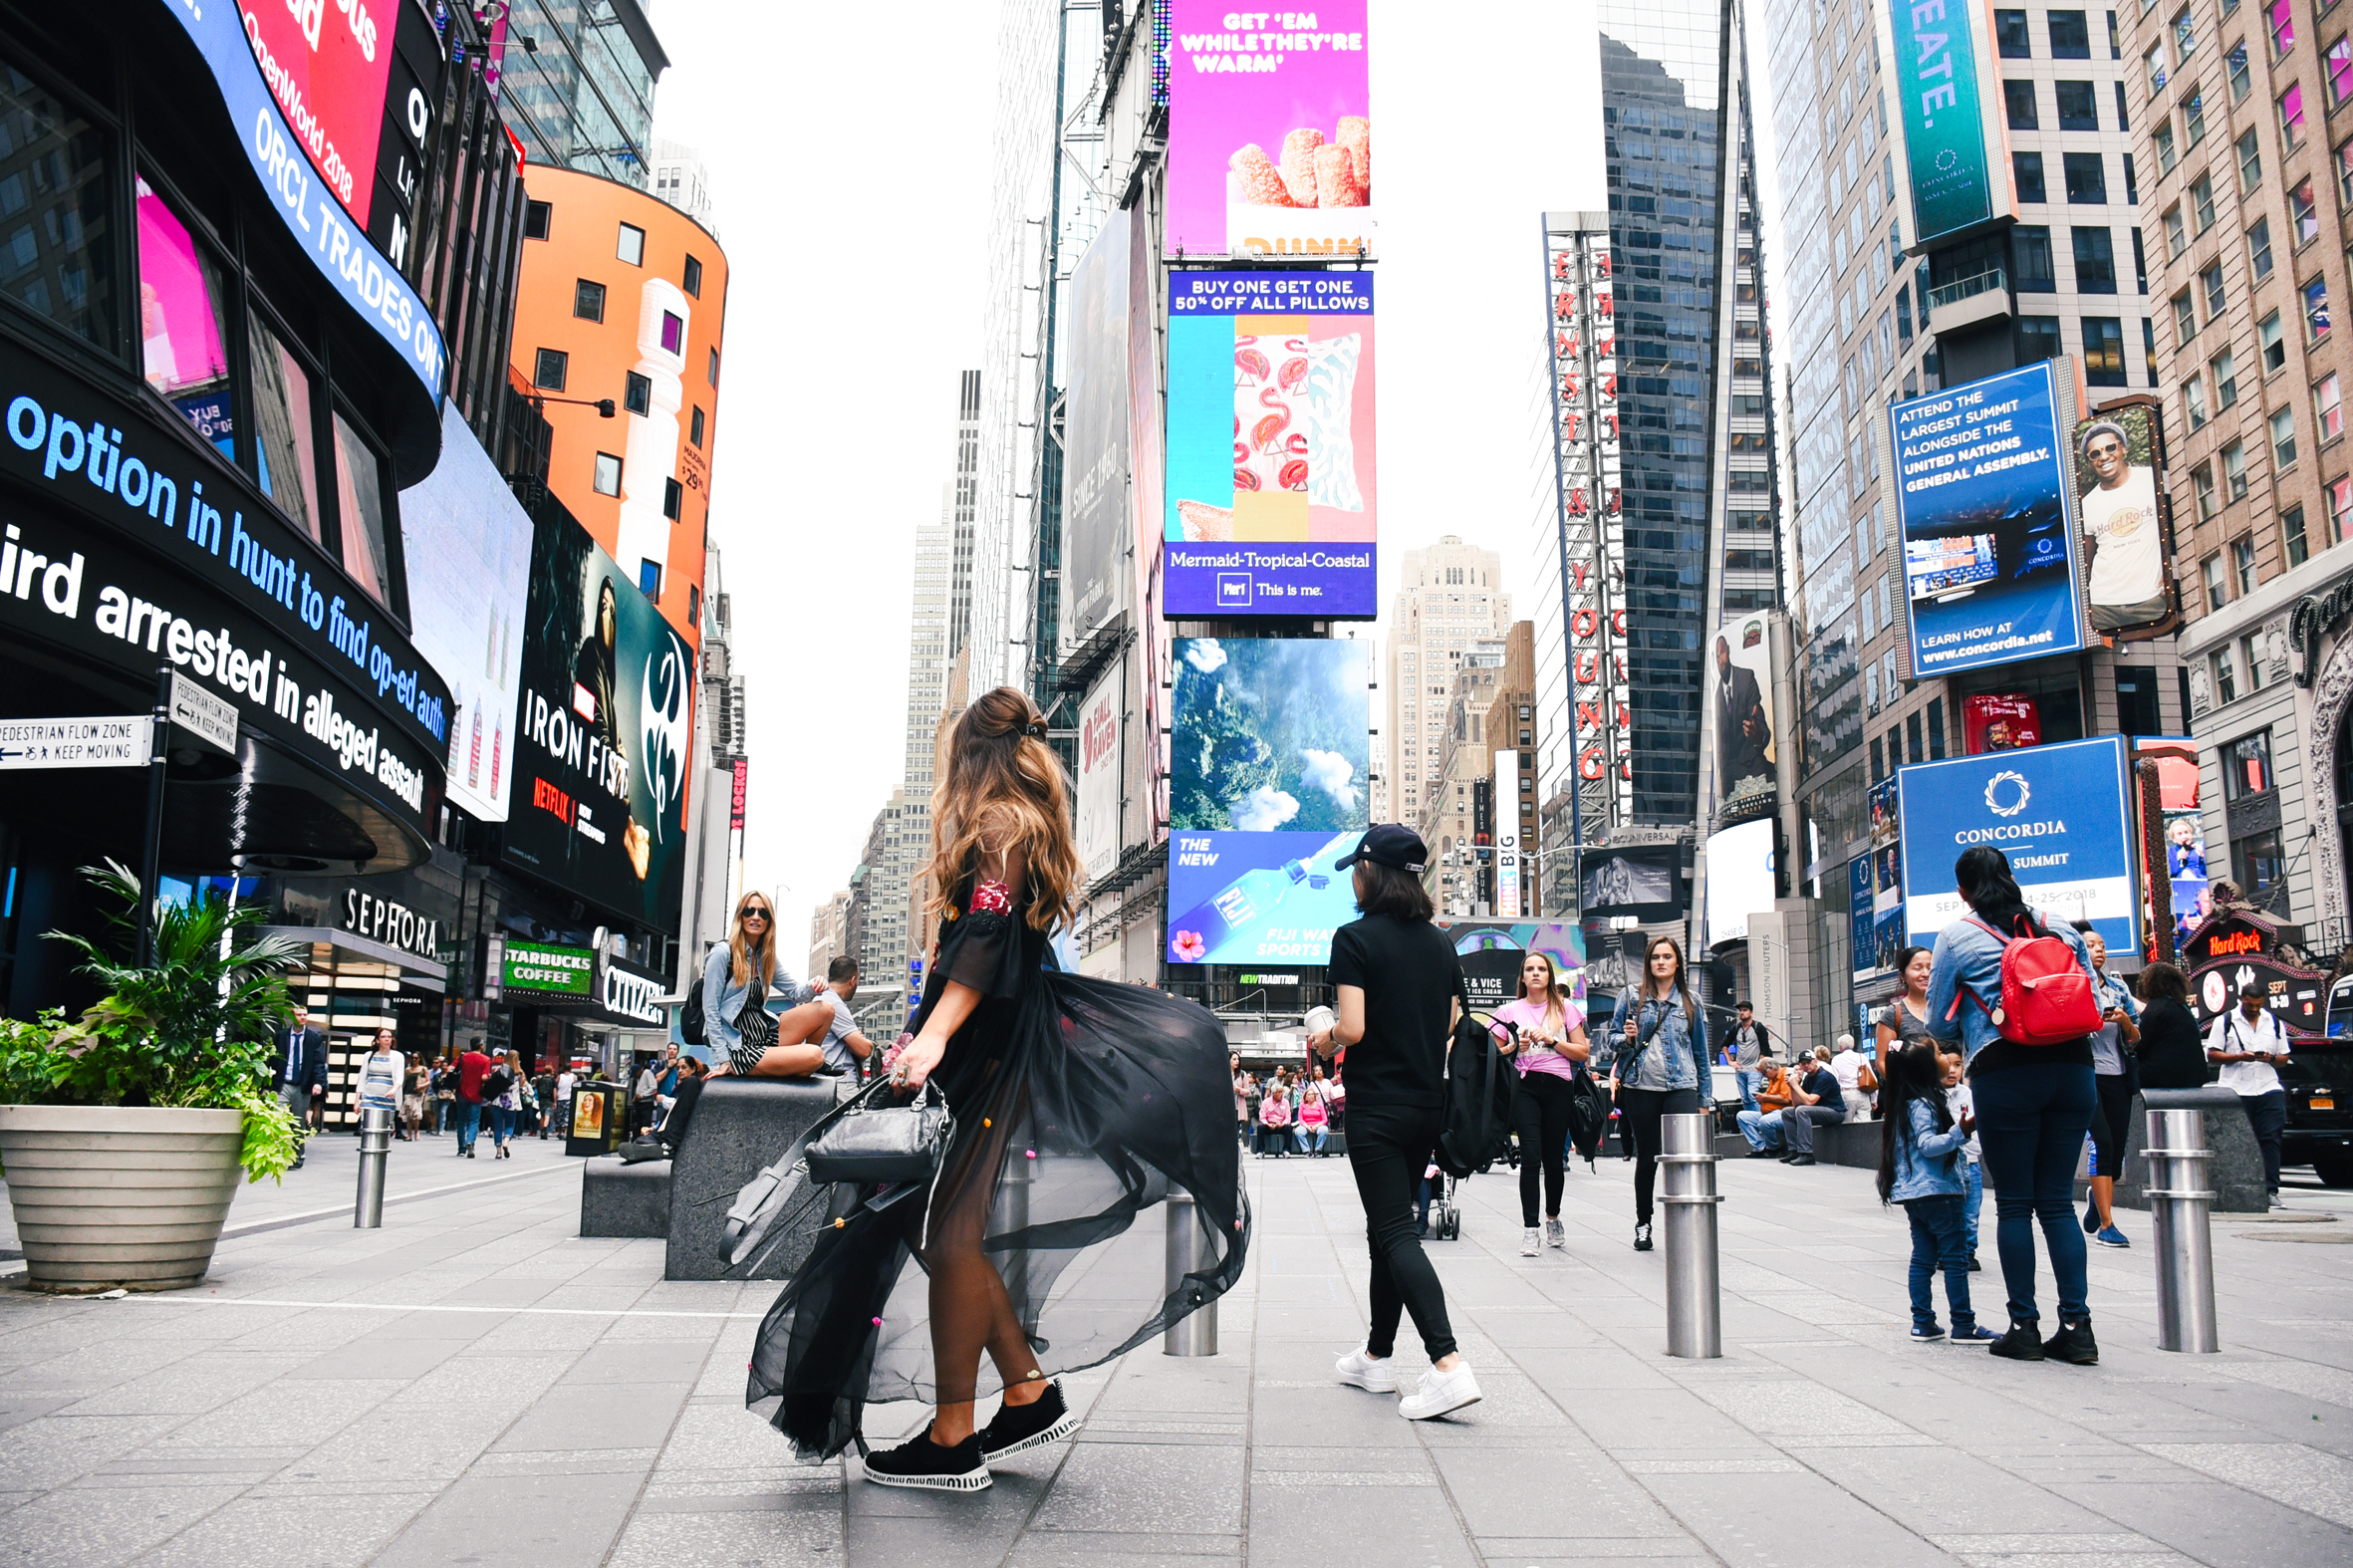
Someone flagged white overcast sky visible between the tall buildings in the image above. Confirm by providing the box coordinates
[652,0,1762,958]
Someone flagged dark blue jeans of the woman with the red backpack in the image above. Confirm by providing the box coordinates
[1969,1062,2099,1323]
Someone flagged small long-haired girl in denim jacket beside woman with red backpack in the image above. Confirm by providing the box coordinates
[1880,1043,2000,1344]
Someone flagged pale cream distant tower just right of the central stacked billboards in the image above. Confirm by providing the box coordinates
[1381,534,1510,822]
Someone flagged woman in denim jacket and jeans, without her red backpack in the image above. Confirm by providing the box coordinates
[1927,845,2099,1366]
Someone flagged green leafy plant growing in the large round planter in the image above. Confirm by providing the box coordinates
[0,862,304,1181]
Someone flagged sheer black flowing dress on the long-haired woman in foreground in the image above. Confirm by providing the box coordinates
[746,900,1249,1464]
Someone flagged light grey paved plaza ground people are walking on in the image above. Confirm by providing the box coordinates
[0,1140,2353,1568]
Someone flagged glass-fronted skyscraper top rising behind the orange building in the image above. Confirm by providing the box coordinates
[499,0,663,188]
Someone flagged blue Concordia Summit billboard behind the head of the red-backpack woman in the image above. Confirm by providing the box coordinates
[1897,734,2141,953]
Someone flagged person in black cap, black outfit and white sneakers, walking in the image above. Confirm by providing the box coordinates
[1308,822,1480,1422]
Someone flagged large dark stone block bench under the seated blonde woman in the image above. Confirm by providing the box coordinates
[663,1076,843,1278]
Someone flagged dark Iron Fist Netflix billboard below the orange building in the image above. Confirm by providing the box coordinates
[506,513,694,934]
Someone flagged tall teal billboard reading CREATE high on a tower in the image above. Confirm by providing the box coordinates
[1887,0,2012,245]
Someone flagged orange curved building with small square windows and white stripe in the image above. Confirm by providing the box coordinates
[513,164,727,648]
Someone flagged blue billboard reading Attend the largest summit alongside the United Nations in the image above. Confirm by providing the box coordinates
[1887,361,2085,678]
